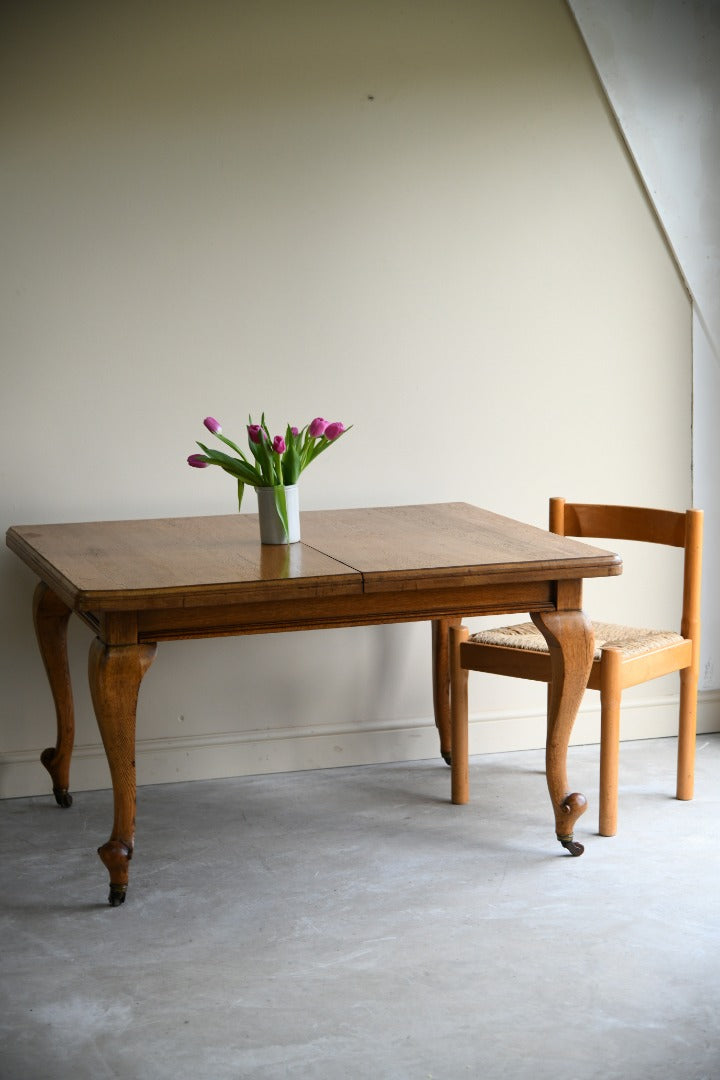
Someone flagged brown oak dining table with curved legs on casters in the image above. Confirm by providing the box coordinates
[6,502,622,906]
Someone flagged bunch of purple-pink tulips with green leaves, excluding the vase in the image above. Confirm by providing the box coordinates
[188,413,350,532]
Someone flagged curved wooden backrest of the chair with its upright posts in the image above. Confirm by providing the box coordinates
[549,498,703,640]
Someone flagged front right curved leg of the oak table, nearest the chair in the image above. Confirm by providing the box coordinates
[531,610,594,855]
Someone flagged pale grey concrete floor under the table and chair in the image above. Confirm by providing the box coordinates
[0,735,720,1080]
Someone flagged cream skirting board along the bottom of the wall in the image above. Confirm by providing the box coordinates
[0,690,720,799]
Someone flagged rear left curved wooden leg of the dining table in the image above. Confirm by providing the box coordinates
[32,581,74,807]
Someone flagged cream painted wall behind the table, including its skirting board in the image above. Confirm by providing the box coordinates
[0,0,708,795]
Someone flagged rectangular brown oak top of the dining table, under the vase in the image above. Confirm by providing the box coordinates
[6,502,621,612]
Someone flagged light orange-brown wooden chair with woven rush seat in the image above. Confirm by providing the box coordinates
[451,499,703,836]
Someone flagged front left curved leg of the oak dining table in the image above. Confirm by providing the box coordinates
[89,637,157,907]
